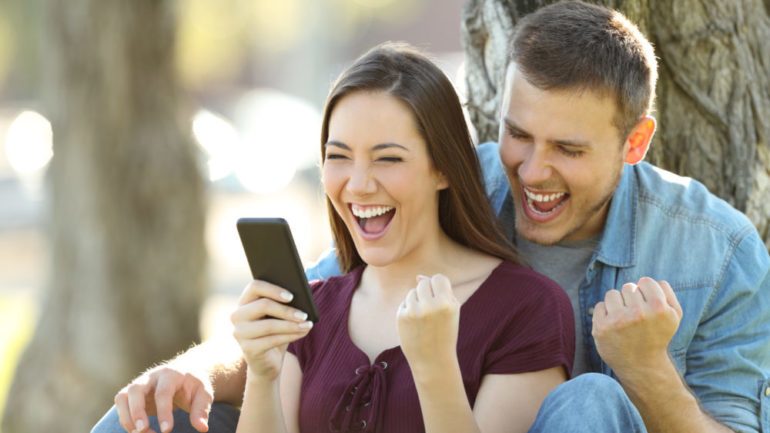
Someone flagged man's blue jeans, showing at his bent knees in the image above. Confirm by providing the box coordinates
[91,373,647,433]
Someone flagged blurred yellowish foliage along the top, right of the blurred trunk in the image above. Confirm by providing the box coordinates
[177,0,423,89]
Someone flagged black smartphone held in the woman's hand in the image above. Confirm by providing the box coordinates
[237,218,318,323]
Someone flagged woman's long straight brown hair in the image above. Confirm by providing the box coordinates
[321,42,519,273]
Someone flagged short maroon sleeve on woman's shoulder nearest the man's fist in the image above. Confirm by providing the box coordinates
[484,280,575,377]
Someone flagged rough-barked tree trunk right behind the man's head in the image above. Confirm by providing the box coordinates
[463,0,770,248]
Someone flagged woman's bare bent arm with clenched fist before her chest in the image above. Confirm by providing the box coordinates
[398,275,566,433]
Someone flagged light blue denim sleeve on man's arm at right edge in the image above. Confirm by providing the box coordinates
[685,227,770,433]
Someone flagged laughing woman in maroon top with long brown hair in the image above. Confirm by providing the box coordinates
[232,44,574,433]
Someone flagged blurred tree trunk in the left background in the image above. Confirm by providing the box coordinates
[2,0,206,433]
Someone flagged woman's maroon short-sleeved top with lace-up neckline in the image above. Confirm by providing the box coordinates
[289,262,575,433]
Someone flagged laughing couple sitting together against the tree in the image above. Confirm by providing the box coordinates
[94,2,770,433]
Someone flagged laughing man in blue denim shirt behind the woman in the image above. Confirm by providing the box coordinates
[94,2,770,433]
